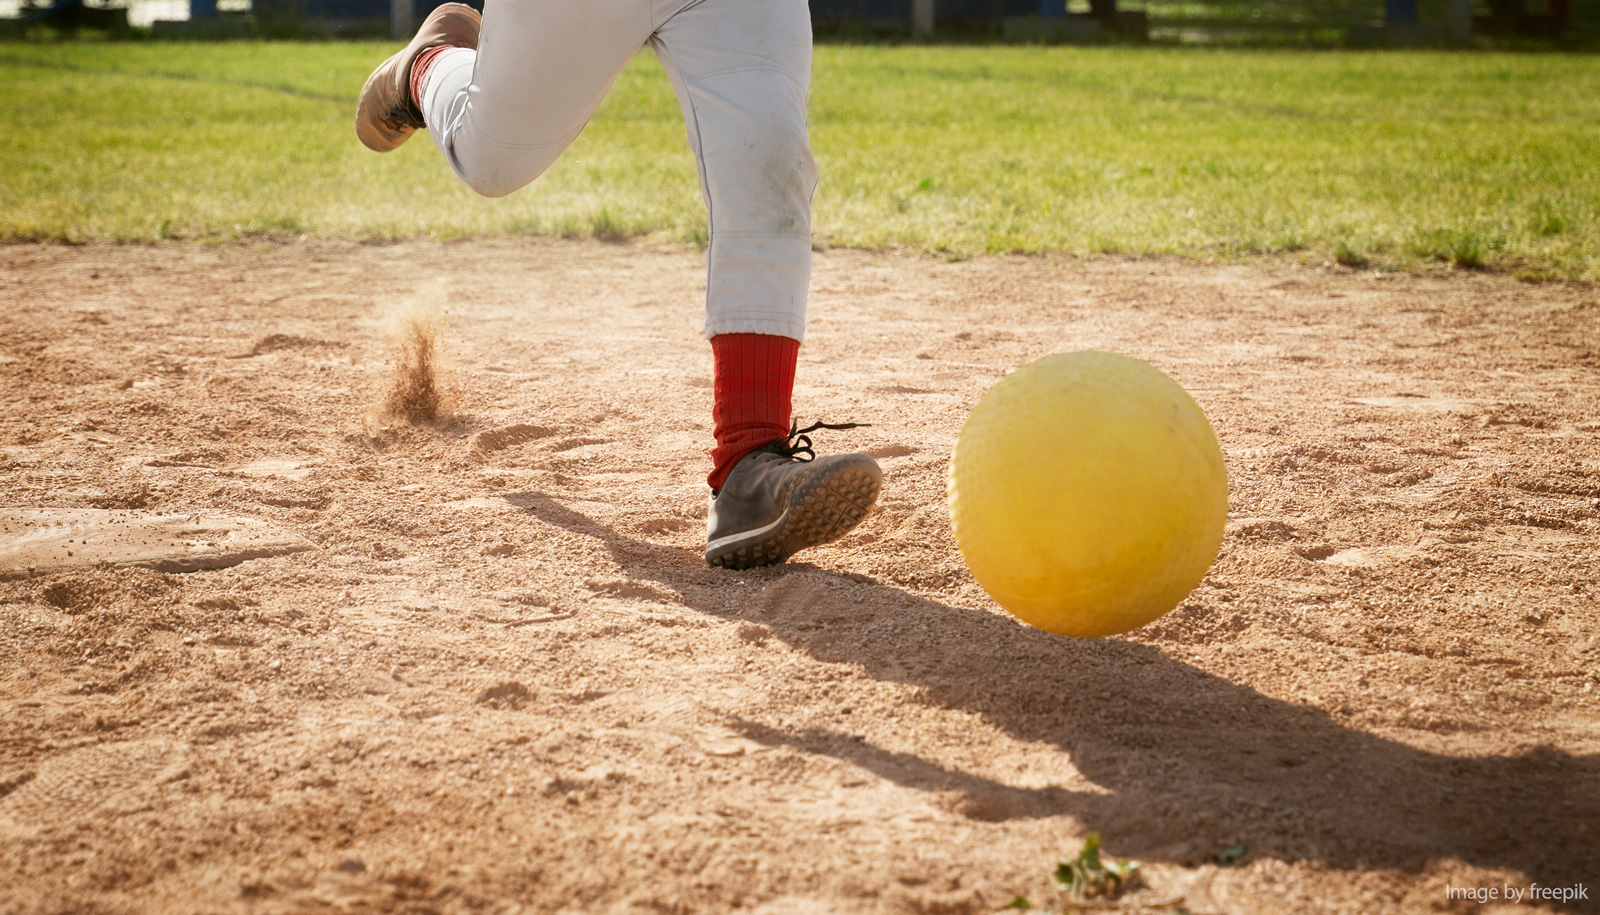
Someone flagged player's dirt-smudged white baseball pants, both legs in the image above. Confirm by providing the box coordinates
[419,0,816,339]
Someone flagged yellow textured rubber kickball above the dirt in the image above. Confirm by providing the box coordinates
[949,352,1227,637]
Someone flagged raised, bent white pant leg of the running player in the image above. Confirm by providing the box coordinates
[418,0,654,197]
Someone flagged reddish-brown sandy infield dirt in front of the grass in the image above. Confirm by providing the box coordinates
[0,240,1600,915]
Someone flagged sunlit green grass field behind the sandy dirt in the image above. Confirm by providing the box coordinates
[0,43,1600,280]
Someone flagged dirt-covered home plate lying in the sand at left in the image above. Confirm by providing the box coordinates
[0,509,317,579]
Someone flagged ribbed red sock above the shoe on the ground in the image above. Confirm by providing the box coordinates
[706,334,800,491]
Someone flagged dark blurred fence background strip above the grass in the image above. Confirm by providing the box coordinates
[0,0,1600,46]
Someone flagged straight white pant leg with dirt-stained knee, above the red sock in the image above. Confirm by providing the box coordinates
[651,0,816,339]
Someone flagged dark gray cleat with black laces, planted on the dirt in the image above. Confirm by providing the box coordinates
[706,422,883,569]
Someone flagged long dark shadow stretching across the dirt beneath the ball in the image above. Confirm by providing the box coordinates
[509,493,1600,910]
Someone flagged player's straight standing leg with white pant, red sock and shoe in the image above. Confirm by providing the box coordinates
[651,0,882,568]
